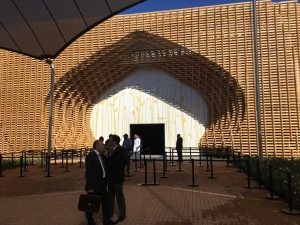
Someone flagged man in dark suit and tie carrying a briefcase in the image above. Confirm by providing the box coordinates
[85,140,116,225]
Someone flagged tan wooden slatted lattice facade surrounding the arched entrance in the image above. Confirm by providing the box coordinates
[0,0,300,157]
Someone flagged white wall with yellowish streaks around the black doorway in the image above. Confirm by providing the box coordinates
[91,66,208,147]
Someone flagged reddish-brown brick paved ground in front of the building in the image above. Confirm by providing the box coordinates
[0,159,300,225]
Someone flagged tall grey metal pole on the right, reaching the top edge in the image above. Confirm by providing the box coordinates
[252,0,263,165]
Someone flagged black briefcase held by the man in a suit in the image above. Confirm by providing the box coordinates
[78,194,101,213]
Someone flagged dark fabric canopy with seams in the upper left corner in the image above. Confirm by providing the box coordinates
[0,0,145,59]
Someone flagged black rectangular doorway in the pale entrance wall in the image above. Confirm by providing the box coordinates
[130,123,165,155]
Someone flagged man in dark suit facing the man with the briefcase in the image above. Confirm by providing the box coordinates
[108,135,128,222]
